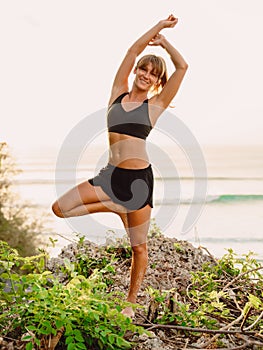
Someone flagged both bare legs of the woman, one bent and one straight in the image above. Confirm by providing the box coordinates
[52,182,151,317]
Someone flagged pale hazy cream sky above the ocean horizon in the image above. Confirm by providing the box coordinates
[0,0,263,155]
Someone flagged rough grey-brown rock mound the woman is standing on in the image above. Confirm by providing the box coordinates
[47,235,217,304]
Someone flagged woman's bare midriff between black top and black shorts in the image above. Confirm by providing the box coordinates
[109,132,149,169]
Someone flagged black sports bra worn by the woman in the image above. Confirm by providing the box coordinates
[107,92,152,140]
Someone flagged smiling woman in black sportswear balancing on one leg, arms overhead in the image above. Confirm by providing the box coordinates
[52,15,187,317]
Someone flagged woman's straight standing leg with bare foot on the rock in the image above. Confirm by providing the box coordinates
[122,205,151,317]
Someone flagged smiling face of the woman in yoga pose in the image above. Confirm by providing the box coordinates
[134,62,159,91]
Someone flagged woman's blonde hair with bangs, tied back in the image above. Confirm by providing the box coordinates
[136,54,168,94]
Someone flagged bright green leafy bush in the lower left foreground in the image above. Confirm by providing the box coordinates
[0,242,143,350]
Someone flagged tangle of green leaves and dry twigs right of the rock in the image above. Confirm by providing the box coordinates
[144,250,263,331]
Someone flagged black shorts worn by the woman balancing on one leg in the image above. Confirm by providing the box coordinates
[88,164,153,210]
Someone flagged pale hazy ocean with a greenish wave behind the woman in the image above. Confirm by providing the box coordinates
[14,145,263,261]
